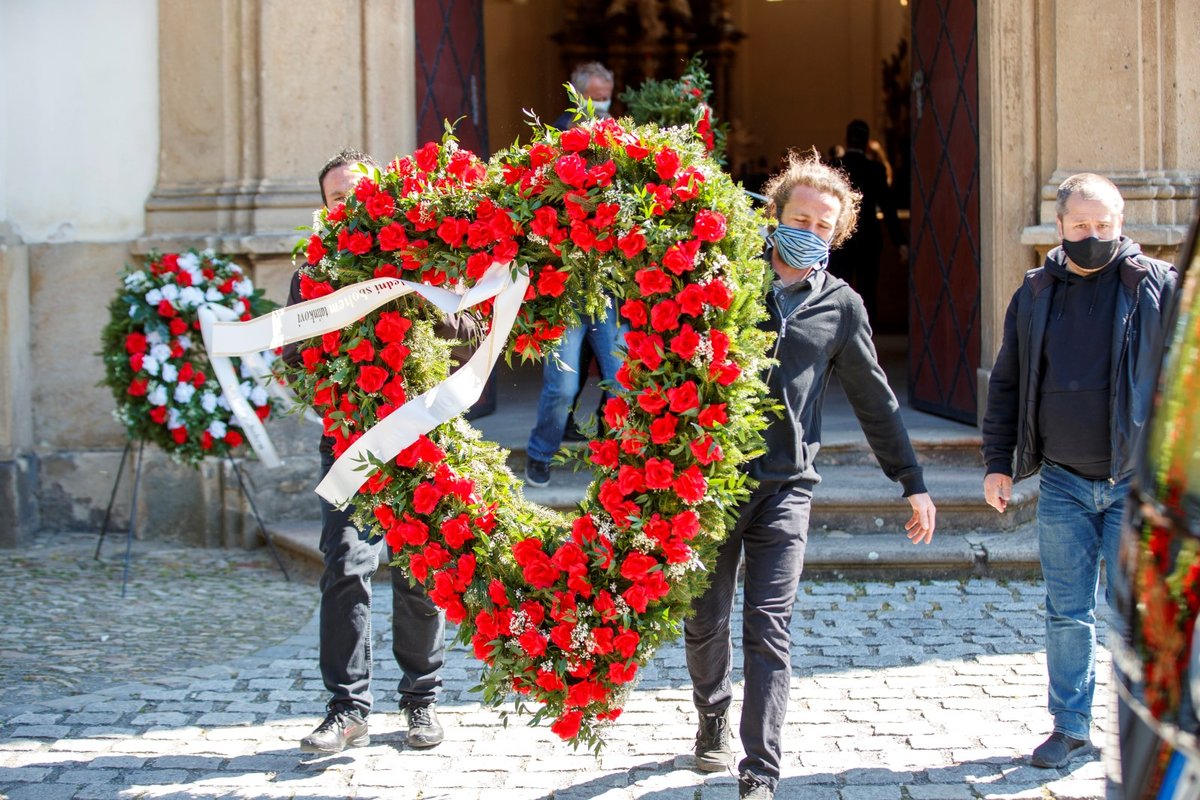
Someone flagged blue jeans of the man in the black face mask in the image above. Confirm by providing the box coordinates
[1038,463,1129,739]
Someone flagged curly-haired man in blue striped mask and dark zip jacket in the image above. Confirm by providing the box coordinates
[684,151,936,800]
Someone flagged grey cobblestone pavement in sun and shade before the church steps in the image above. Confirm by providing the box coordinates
[0,539,1109,800]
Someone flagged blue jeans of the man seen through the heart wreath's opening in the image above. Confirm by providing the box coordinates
[527,308,624,462]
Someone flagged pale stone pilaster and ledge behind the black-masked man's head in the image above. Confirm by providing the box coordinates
[1021,0,1200,260]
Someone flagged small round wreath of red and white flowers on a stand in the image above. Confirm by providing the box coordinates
[98,251,274,467]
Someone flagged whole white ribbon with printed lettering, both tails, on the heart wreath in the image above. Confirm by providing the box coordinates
[202,261,529,506]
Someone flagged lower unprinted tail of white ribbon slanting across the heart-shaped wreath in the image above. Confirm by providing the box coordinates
[317,263,529,506]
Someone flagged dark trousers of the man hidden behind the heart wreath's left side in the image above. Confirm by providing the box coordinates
[320,451,445,716]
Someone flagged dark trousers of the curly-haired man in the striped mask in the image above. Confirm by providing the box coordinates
[684,485,811,786]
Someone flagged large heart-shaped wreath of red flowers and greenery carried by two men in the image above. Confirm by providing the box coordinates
[280,109,769,747]
